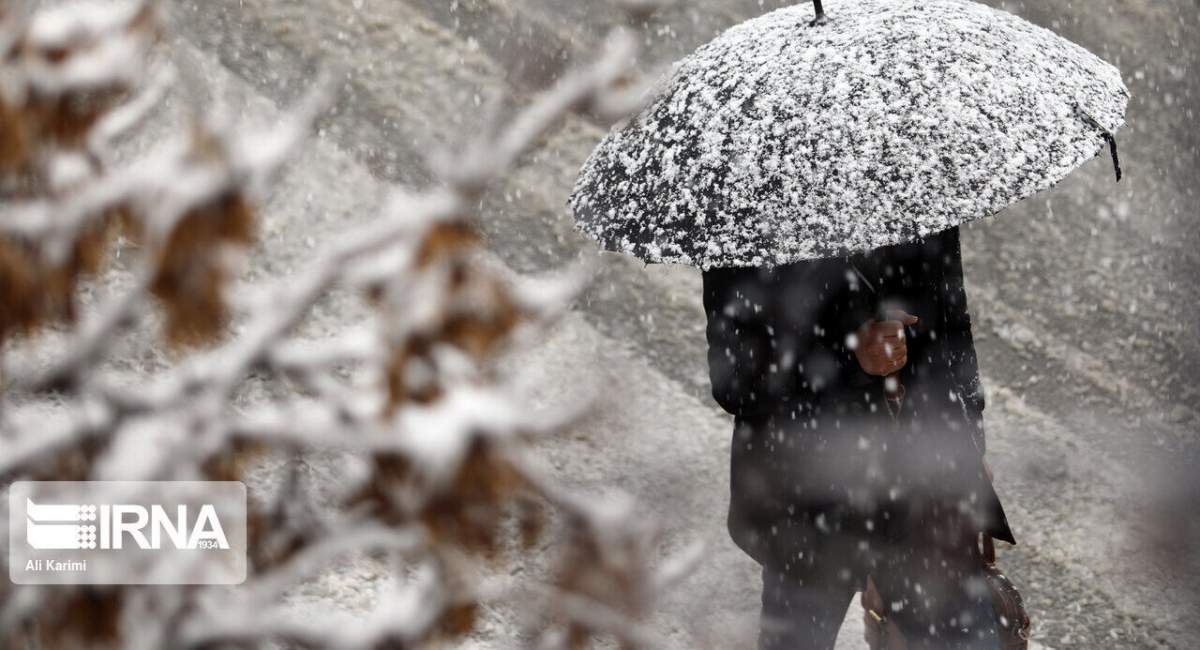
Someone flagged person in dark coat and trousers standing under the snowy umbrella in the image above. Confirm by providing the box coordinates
[703,228,1015,650]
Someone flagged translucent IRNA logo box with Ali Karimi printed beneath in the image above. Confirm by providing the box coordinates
[7,481,246,584]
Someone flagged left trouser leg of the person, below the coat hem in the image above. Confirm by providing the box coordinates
[758,567,857,650]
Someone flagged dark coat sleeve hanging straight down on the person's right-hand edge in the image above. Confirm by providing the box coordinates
[943,228,986,450]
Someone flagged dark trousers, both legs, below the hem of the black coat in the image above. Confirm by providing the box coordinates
[758,537,1000,650]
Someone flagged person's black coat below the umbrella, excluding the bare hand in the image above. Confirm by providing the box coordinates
[704,229,1013,574]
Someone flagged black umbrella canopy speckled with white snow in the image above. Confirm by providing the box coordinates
[571,0,1129,269]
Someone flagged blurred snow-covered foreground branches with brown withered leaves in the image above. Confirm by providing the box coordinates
[0,0,680,649]
